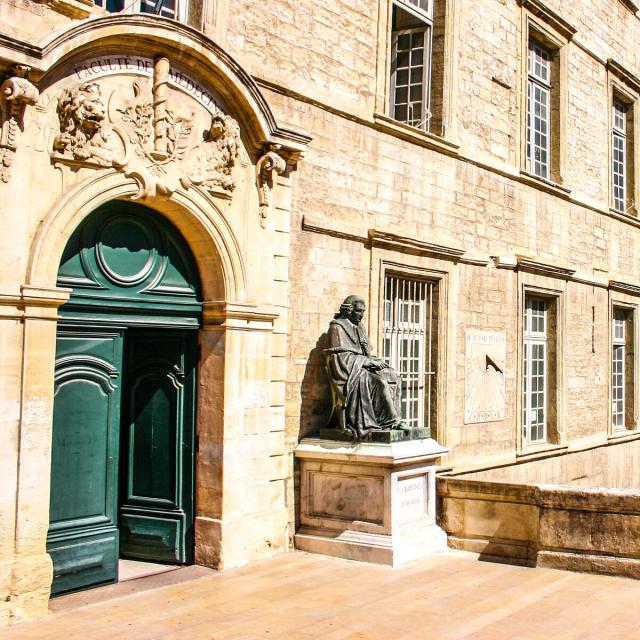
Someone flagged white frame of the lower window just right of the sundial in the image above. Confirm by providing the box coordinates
[522,295,549,444]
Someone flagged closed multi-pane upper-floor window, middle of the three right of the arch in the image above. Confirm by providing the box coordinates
[527,38,551,178]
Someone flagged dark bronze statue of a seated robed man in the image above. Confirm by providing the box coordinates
[324,296,411,439]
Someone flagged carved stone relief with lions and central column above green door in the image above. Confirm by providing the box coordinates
[52,57,240,199]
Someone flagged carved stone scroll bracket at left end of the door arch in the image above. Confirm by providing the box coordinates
[0,65,40,182]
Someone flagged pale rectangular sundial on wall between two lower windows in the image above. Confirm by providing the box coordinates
[464,329,506,424]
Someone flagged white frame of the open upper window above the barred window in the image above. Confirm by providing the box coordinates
[389,0,434,131]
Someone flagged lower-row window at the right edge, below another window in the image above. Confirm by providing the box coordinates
[611,307,635,430]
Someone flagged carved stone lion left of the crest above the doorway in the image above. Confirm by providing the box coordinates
[53,82,126,167]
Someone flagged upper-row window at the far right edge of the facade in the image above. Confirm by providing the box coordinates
[611,96,634,213]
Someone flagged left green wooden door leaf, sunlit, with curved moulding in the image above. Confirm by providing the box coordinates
[47,327,122,595]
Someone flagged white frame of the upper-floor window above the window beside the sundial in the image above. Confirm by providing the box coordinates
[526,36,553,180]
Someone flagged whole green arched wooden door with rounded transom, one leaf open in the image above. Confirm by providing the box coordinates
[47,201,202,595]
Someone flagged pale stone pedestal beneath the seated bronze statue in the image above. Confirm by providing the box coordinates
[295,438,447,566]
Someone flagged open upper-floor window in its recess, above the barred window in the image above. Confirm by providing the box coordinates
[390,0,446,135]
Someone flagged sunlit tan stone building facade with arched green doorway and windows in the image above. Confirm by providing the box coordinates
[0,0,640,622]
